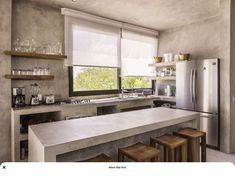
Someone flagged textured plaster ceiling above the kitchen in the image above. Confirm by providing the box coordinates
[28,0,220,30]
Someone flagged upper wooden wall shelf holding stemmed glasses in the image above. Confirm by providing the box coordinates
[3,50,67,60]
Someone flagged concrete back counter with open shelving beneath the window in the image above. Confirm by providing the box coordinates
[11,95,175,162]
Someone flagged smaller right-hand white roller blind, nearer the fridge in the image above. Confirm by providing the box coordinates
[121,30,157,77]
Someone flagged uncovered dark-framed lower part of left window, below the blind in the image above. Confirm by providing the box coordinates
[70,66,119,96]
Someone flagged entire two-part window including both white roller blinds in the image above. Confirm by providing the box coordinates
[62,9,157,96]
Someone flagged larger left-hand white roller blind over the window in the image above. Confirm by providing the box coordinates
[65,17,120,67]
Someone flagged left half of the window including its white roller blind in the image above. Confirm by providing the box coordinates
[66,18,121,96]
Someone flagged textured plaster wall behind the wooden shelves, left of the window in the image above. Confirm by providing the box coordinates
[12,0,68,103]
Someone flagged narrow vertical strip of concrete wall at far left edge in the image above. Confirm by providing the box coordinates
[0,0,11,163]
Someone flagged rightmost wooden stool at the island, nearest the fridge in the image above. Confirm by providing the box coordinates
[174,128,206,162]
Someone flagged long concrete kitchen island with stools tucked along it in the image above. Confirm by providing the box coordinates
[29,108,200,162]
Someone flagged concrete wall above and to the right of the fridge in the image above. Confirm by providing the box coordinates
[159,0,231,153]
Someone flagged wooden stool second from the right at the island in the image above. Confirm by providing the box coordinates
[150,134,187,162]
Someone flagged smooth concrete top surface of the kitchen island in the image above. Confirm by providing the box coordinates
[30,108,198,147]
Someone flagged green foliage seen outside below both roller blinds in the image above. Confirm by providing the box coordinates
[73,67,151,92]
